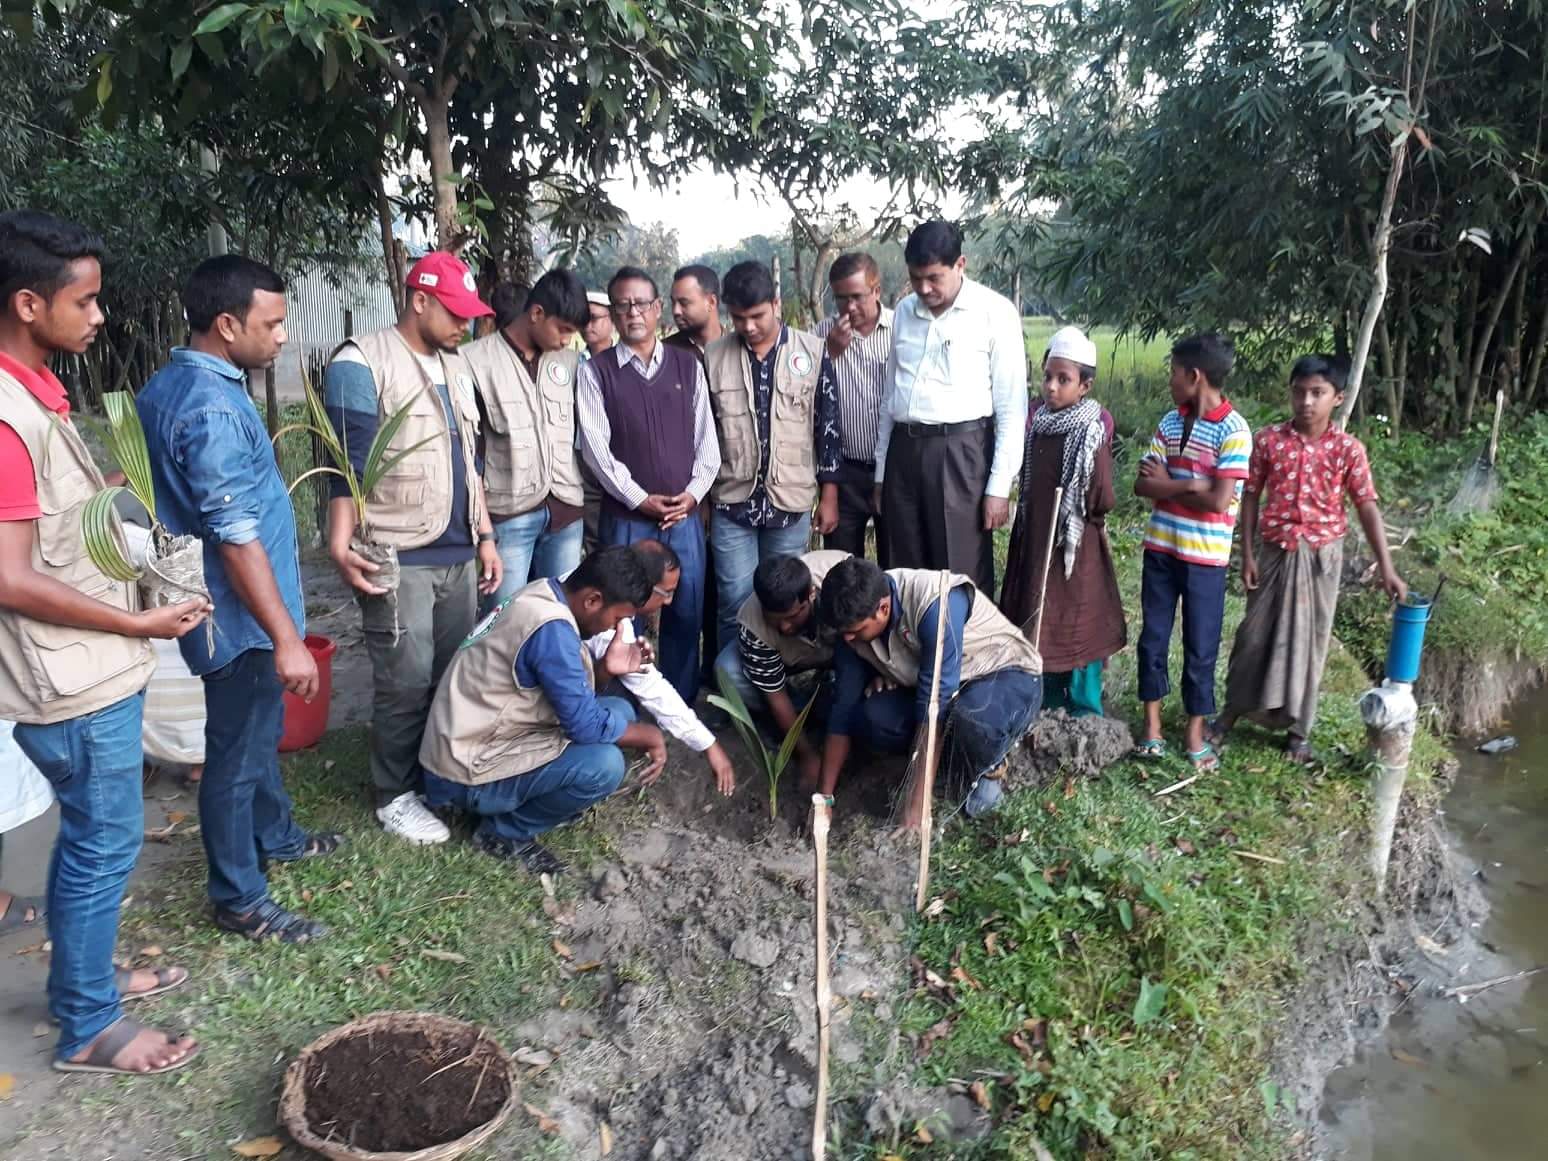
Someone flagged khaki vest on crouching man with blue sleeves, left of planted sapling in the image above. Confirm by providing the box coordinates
[420,579,593,786]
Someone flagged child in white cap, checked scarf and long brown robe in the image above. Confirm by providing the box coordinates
[1000,327,1127,717]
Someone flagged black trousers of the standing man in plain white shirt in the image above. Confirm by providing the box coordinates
[881,420,994,593]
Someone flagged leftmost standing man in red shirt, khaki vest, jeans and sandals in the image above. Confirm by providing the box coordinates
[0,211,209,1076]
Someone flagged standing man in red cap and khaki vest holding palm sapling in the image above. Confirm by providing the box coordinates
[325,252,500,844]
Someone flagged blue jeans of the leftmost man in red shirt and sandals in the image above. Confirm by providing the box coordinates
[15,694,146,1060]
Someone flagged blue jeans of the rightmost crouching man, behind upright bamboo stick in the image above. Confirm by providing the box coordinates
[853,669,1043,794]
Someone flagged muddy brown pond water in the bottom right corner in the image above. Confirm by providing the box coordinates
[1322,690,1548,1161]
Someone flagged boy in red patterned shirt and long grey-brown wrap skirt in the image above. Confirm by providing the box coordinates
[1209,354,1409,763]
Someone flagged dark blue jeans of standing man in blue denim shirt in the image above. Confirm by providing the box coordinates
[198,649,307,913]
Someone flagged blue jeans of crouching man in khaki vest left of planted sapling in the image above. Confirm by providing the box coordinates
[424,697,635,844]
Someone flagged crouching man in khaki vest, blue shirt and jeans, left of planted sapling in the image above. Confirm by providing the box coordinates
[420,546,667,873]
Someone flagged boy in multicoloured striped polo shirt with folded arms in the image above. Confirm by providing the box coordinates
[1135,333,1252,771]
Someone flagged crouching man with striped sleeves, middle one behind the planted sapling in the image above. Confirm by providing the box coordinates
[715,550,850,783]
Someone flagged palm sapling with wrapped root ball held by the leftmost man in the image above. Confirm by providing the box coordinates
[80,392,214,637]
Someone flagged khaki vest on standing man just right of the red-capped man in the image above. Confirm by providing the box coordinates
[463,331,585,515]
